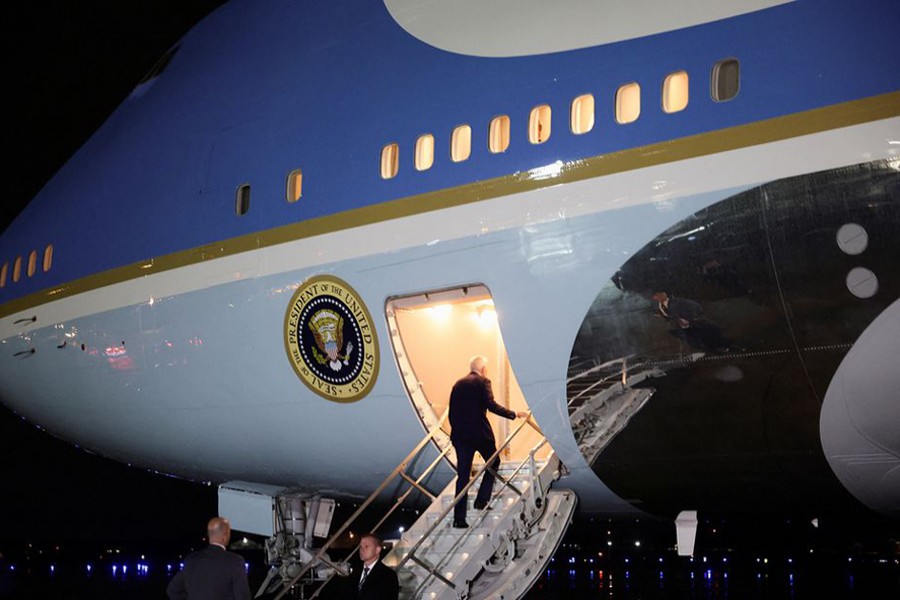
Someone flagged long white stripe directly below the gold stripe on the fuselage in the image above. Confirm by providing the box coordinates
[0,117,900,339]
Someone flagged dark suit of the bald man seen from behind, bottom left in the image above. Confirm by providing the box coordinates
[166,544,250,600]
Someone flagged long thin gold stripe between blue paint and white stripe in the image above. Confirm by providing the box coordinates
[0,92,900,317]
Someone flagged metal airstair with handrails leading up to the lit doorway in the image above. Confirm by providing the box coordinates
[275,414,577,600]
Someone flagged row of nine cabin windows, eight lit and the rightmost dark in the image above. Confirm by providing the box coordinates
[381,58,740,179]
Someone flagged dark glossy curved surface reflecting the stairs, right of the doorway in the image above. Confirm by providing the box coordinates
[567,161,900,516]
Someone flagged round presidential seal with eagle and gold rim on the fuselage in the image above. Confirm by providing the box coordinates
[284,275,378,402]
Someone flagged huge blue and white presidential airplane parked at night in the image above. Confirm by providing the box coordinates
[0,0,900,597]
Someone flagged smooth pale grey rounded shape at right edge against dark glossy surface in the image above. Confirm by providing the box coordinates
[819,300,900,517]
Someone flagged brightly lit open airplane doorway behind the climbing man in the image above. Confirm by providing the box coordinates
[385,284,552,462]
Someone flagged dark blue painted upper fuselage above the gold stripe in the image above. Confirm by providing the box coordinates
[0,0,900,303]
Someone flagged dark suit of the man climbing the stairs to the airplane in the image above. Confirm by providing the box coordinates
[450,372,516,523]
